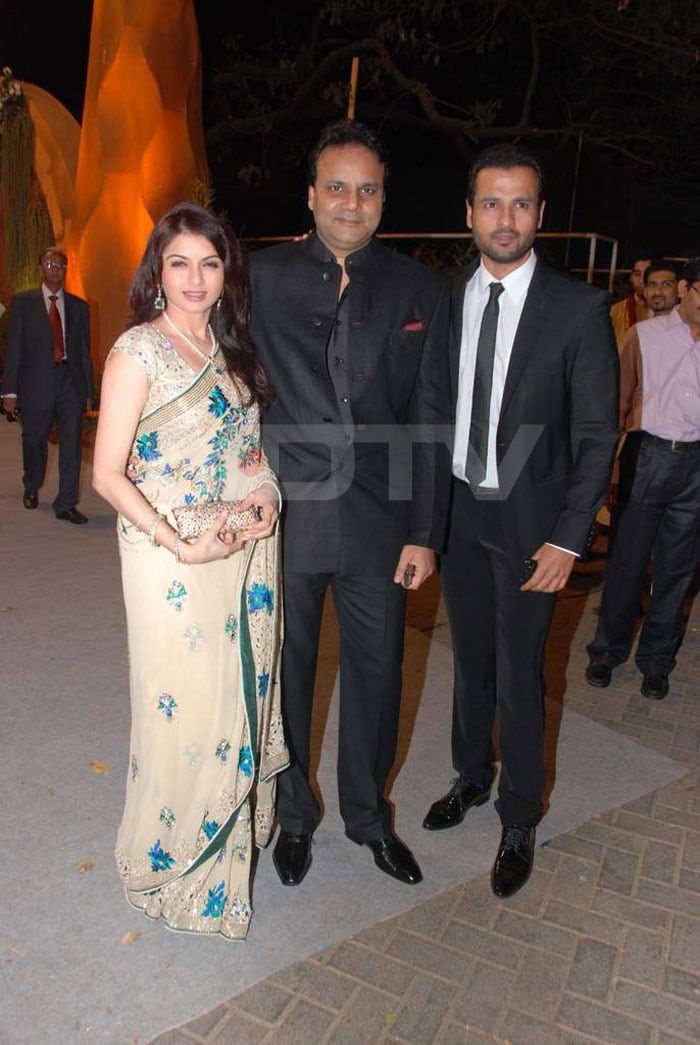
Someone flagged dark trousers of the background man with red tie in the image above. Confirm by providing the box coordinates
[21,366,83,512]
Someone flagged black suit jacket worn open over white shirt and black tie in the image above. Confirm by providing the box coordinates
[450,261,619,562]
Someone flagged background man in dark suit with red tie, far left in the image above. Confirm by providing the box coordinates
[2,247,92,525]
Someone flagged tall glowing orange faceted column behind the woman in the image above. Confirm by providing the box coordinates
[66,0,208,371]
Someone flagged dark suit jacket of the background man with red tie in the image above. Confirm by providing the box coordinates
[2,288,92,410]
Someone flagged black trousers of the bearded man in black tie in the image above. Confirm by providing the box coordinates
[441,482,555,827]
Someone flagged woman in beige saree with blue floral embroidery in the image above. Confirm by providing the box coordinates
[93,204,288,939]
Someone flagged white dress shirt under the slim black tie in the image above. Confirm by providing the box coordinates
[452,251,537,490]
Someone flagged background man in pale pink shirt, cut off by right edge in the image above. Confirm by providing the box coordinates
[586,257,700,700]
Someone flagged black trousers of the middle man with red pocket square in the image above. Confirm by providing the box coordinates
[277,572,405,841]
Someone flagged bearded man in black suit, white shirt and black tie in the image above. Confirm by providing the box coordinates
[423,145,617,897]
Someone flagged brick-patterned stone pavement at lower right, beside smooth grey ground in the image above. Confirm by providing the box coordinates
[157,551,700,1045]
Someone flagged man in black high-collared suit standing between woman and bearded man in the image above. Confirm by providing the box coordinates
[251,121,449,885]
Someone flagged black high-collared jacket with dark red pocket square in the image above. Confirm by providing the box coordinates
[250,235,449,576]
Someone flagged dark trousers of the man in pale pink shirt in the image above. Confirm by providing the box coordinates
[588,435,700,675]
